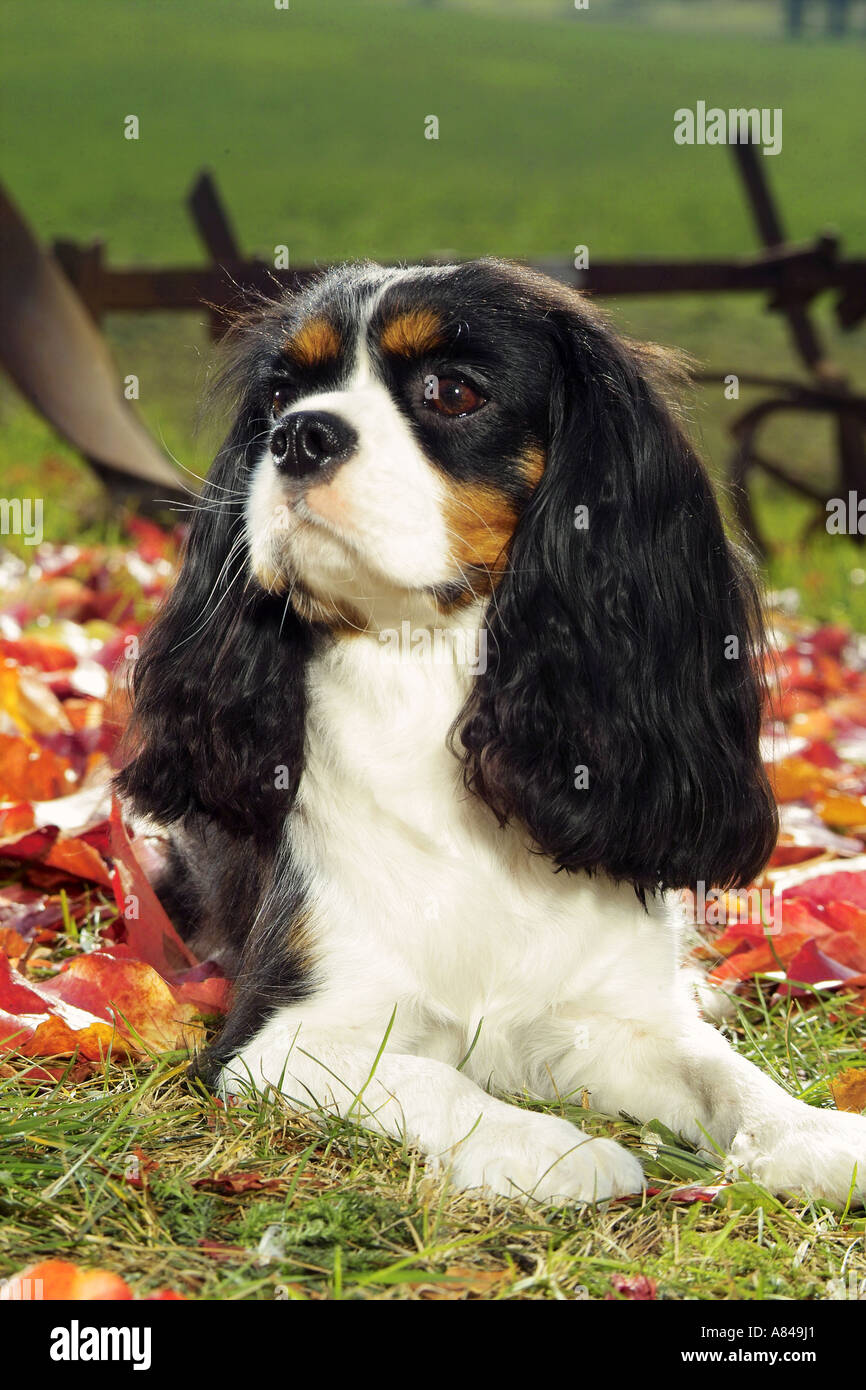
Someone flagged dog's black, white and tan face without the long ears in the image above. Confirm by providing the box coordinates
[239,265,549,627]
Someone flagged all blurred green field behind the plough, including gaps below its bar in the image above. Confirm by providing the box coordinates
[0,0,866,627]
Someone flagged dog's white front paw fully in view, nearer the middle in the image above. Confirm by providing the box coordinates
[446,1109,644,1202]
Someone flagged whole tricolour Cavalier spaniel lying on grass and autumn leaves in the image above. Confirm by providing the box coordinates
[120,260,866,1202]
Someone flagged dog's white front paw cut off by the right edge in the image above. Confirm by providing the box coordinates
[728,1105,866,1202]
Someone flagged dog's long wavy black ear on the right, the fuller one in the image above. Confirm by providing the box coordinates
[456,298,777,892]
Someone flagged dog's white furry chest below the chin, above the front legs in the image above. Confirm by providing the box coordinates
[292,638,669,1058]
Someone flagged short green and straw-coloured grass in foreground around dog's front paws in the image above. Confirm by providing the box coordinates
[0,987,866,1301]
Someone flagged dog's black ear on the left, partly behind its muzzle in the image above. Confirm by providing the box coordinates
[117,391,309,841]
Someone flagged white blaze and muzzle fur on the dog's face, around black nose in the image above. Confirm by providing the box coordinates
[246,286,455,588]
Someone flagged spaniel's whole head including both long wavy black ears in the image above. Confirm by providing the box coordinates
[121,261,776,891]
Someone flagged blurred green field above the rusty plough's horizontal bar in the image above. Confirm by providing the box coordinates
[3,0,866,261]
